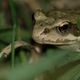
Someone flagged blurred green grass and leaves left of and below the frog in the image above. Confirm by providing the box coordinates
[0,0,80,80]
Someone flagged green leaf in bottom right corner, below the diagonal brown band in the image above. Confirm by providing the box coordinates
[57,64,80,80]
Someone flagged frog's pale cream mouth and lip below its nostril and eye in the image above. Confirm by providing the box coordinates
[35,34,80,45]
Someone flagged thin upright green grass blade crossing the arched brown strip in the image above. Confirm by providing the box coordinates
[9,0,18,68]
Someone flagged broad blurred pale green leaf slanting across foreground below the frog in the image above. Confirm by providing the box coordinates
[8,50,77,80]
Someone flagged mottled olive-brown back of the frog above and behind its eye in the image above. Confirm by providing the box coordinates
[48,9,80,23]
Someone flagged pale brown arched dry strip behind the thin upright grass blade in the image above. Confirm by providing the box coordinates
[0,41,41,63]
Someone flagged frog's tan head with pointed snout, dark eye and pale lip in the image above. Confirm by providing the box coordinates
[32,11,80,45]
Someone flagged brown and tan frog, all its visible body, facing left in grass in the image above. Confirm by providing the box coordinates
[32,10,80,52]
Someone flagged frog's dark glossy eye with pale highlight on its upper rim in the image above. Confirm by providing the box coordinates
[56,23,71,35]
